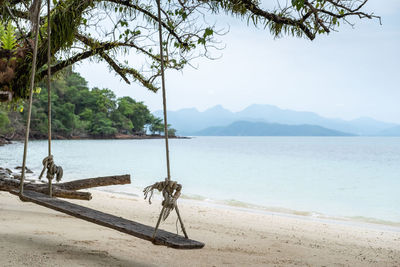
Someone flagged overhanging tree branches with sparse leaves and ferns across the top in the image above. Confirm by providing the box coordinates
[0,0,378,99]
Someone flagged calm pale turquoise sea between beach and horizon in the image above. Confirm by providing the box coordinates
[0,137,400,225]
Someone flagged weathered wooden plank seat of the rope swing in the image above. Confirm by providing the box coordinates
[11,190,204,249]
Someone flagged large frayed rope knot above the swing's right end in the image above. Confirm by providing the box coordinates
[143,178,182,221]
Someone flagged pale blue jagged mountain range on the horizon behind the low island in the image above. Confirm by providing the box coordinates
[154,104,400,136]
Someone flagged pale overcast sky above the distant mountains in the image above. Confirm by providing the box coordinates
[75,0,400,123]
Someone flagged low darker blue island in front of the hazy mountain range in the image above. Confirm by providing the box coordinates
[194,121,354,136]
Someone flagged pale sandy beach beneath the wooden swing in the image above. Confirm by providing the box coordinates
[0,191,400,266]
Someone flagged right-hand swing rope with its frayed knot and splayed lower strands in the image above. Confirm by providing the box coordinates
[143,0,188,239]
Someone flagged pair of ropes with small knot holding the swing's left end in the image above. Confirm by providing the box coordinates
[20,0,63,197]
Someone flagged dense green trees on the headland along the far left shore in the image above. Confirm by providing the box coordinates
[0,69,174,138]
